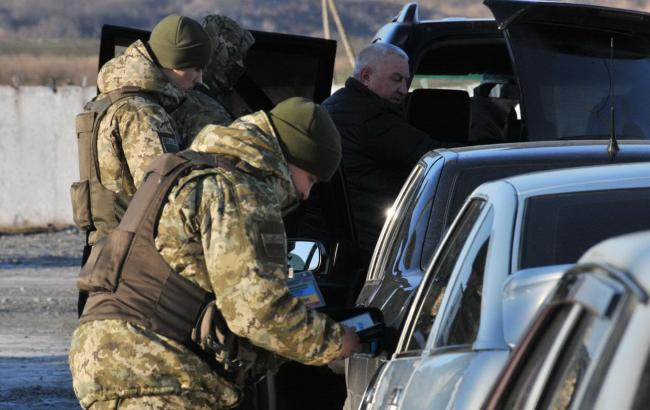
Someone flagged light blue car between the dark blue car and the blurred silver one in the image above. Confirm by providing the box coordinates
[361,163,650,409]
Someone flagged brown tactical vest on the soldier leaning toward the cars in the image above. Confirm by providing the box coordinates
[77,151,258,380]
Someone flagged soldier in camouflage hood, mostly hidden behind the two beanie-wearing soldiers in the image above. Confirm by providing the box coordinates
[172,15,255,147]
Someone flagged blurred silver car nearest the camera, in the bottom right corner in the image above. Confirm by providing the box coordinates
[485,231,650,410]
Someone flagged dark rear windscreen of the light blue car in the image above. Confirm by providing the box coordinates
[519,189,650,269]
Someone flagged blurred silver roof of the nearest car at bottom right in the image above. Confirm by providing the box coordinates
[578,231,650,292]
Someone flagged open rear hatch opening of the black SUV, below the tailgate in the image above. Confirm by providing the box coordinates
[406,36,521,146]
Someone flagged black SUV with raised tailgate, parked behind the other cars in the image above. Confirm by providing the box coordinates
[373,0,650,144]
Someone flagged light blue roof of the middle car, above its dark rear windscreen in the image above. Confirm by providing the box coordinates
[492,158,650,199]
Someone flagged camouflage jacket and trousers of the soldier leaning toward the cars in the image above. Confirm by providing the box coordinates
[69,112,343,408]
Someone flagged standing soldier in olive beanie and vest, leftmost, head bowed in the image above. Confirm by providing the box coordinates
[72,15,212,318]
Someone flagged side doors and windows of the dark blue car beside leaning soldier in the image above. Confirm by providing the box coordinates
[346,154,444,408]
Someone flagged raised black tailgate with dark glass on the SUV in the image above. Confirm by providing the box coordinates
[485,0,650,141]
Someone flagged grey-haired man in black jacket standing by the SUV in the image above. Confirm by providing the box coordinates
[323,43,440,256]
